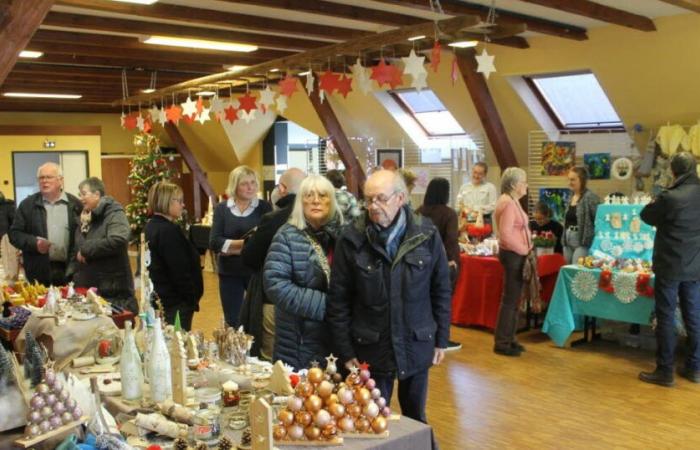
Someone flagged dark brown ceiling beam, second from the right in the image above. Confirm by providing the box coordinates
[376,0,588,41]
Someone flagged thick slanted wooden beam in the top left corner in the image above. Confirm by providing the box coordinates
[0,0,54,84]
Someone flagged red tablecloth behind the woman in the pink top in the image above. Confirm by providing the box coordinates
[452,253,565,329]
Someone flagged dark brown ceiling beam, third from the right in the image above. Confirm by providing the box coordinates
[217,0,425,27]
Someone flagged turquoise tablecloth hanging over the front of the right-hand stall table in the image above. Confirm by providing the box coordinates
[542,265,654,347]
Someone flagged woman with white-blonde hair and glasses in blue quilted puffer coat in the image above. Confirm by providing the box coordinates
[263,175,343,370]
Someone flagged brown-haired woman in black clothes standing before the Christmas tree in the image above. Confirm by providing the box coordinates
[145,181,204,331]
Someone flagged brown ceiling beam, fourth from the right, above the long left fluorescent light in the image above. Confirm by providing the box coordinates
[56,0,367,40]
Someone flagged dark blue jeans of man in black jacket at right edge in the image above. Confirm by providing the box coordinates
[654,276,700,373]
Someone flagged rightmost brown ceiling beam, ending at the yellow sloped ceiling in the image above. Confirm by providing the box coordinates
[522,0,656,31]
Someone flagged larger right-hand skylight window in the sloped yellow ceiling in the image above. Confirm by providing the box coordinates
[526,73,623,130]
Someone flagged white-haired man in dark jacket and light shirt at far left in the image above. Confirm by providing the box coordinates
[9,163,82,286]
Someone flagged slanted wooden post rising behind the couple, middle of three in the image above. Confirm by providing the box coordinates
[299,74,365,196]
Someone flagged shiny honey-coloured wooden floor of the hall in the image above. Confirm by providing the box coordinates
[194,272,700,450]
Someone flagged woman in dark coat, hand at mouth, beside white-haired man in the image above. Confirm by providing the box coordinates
[73,177,139,314]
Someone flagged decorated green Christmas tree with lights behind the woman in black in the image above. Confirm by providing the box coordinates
[126,133,174,236]
